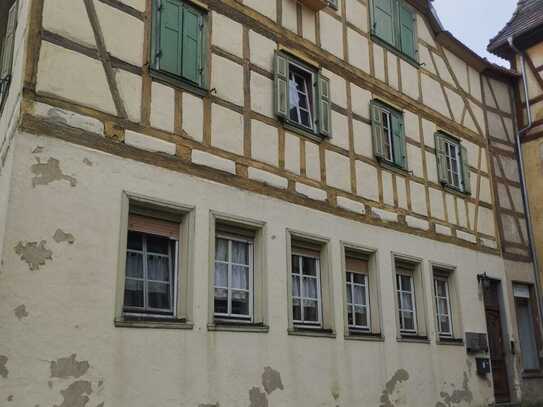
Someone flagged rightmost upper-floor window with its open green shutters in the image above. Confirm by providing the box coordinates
[435,133,471,194]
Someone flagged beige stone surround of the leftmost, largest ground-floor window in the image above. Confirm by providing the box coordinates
[115,191,195,329]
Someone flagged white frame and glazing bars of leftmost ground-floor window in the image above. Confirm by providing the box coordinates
[123,230,179,318]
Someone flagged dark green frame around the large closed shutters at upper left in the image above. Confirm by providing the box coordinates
[148,0,211,96]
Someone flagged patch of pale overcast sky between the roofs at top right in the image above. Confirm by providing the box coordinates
[434,0,517,65]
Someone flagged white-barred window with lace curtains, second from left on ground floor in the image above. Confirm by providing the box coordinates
[214,231,253,321]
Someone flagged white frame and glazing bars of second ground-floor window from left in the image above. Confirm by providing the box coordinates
[213,233,254,323]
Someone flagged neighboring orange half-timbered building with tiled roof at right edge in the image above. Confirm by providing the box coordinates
[488,0,543,402]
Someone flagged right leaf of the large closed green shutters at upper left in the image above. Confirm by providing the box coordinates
[181,5,203,85]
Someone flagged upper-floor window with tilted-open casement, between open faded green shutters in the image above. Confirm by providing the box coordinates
[274,52,331,136]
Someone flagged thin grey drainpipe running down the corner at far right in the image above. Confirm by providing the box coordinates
[507,36,543,319]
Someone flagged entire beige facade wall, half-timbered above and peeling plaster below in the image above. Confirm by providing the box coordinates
[0,0,533,407]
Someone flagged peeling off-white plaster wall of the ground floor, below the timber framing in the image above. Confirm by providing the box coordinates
[0,135,505,407]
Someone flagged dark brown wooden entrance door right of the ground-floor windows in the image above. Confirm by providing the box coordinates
[484,281,511,403]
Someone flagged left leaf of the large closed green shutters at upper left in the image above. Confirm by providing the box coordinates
[156,0,183,76]
